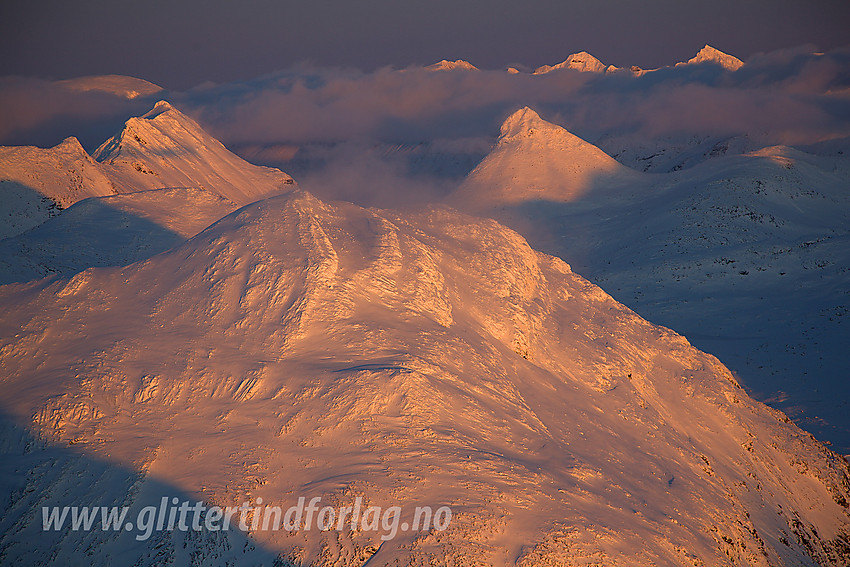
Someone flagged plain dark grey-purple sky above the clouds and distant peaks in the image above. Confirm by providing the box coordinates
[0,0,850,90]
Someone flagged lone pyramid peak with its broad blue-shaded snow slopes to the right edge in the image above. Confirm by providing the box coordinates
[451,110,850,453]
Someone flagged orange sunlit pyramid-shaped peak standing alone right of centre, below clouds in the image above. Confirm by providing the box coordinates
[449,107,634,209]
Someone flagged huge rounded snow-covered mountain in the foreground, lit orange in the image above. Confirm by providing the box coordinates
[0,192,850,566]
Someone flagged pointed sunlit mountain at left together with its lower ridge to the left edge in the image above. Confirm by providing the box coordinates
[0,101,293,243]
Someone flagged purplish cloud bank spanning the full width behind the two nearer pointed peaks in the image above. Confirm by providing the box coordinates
[0,46,850,184]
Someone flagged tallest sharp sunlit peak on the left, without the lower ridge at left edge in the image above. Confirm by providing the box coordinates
[94,100,293,204]
